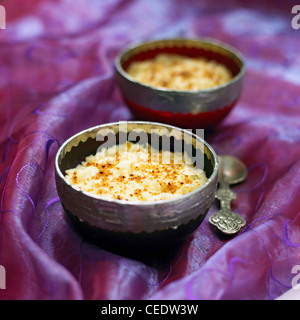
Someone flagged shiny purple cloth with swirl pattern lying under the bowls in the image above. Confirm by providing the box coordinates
[0,0,300,300]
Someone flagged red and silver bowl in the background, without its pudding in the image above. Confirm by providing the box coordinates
[115,38,245,129]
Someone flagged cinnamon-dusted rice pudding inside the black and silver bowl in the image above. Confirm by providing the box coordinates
[66,142,207,201]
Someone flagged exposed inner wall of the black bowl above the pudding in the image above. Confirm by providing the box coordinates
[58,122,215,178]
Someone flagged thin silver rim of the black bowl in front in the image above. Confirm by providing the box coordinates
[55,121,219,207]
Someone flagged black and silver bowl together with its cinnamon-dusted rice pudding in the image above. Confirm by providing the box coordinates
[55,121,219,252]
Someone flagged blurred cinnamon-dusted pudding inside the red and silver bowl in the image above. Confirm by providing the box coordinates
[127,53,232,90]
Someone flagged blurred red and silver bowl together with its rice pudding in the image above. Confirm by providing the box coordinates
[115,39,245,129]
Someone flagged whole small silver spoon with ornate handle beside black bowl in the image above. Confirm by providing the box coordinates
[209,155,247,234]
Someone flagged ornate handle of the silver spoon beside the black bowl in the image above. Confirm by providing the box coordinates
[209,183,246,234]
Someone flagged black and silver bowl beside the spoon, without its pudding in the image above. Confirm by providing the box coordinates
[55,121,219,253]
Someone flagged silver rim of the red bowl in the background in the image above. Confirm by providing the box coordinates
[115,37,246,95]
